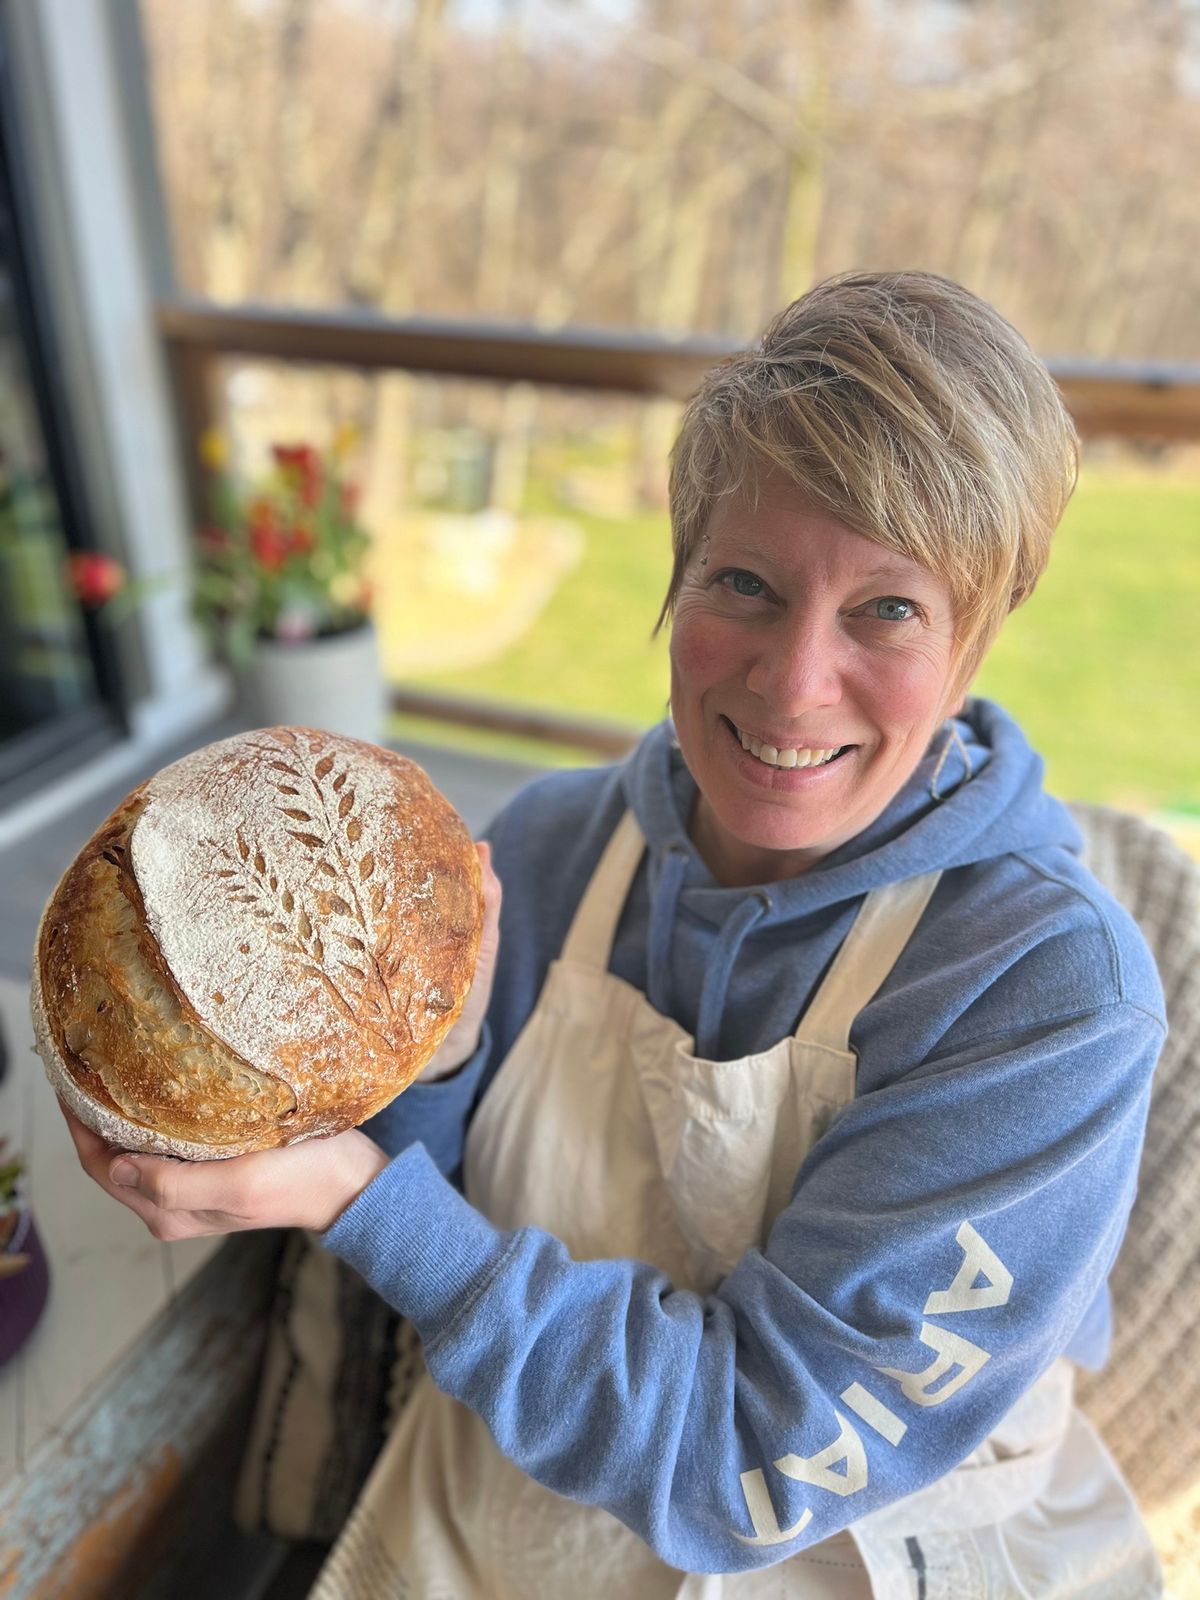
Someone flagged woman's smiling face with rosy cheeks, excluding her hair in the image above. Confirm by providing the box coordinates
[670,478,962,883]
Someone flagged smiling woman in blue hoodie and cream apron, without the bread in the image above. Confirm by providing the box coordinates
[65,274,1163,1600]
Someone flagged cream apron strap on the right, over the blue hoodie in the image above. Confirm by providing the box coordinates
[795,872,941,1051]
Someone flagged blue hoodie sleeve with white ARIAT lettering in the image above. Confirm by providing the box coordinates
[326,971,1162,1571]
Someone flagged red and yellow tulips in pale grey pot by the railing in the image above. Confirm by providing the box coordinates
[69,432,386,741]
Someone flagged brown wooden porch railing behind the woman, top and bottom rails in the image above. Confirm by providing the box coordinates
[158,298,1200,755]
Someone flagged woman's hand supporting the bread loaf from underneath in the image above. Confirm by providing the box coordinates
[59,1101,389,1240]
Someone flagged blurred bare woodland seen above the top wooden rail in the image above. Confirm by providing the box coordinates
[141,0,1200,360]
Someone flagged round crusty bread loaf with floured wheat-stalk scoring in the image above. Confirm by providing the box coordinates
[32,728,483,1160]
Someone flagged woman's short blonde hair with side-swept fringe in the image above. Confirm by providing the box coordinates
[659,272,1078,683]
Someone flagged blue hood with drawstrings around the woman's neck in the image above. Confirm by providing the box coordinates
[622,699,1080,1048]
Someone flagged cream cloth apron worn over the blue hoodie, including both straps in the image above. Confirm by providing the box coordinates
[312,813,1160,1600]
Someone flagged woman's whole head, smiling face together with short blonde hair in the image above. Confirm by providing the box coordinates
[659,274,1077,885]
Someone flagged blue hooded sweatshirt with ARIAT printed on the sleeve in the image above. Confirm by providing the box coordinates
[325,701,1165,1571]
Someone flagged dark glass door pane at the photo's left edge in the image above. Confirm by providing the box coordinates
[0,261,96,744]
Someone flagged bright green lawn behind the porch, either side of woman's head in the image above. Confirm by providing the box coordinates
[387,467,1200,811]
